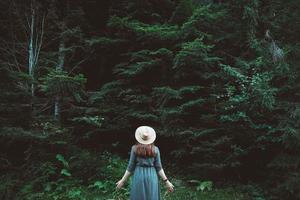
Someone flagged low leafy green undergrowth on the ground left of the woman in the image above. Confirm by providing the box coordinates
[0,149,129,200]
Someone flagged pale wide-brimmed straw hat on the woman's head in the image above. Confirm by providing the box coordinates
[135,126,156,144]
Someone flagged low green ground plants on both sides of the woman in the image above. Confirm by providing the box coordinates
[0,152,255,200]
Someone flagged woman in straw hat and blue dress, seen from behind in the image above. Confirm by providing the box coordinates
[116,126,174,200]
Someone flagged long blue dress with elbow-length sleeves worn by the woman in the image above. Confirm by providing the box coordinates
[127,146,162,200]
